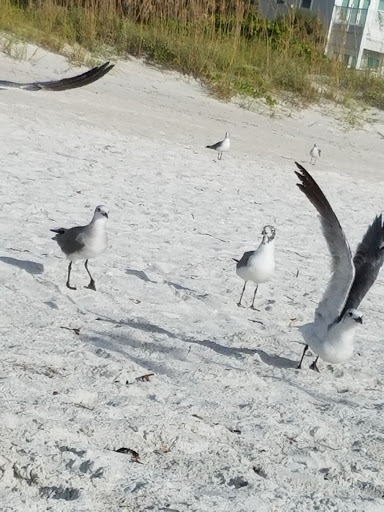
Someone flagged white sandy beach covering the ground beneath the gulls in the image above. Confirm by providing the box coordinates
[0,46,384,512]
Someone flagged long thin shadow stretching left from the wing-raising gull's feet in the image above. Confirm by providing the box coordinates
[90,317,297,368]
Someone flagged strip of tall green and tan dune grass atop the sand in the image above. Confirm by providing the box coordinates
[0,0,384,108]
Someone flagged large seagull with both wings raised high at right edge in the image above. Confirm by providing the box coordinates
[295,162,384,371]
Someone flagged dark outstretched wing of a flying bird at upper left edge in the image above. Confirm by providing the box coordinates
[0,62,114,91]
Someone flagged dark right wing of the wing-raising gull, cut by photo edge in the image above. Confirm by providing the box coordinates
[340,215,384,317]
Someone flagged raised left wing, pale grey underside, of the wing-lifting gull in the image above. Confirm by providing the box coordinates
[295,162,355,326]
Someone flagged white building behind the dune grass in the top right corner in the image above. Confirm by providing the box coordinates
[259,0,384,69]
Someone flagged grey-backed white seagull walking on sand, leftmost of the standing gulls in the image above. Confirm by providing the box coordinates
[51,205,109,291]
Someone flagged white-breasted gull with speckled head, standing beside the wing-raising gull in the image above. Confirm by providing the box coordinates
[232,225,276,309]
